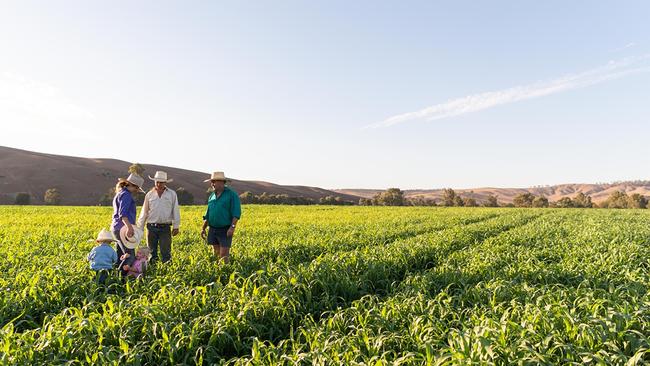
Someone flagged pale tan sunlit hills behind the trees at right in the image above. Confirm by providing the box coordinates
[335,181,650,204]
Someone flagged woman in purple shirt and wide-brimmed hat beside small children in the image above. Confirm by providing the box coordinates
[111,174,144,274]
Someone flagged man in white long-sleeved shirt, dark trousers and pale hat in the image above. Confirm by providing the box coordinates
[138,171,181,263]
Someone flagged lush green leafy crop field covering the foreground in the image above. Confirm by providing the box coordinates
[0,206,650,365]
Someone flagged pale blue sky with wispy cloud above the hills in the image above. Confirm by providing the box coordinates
[0,0,650,189]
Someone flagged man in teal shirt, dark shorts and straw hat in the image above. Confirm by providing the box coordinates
[201,172,241,263]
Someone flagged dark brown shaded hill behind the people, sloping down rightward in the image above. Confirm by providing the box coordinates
[0,146,359,205]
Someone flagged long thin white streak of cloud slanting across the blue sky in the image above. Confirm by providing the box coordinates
[365,55,650,128]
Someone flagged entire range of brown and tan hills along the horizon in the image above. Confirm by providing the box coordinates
[0,146,650,205]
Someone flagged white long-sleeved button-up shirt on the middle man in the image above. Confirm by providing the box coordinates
[138,188,181,229]
